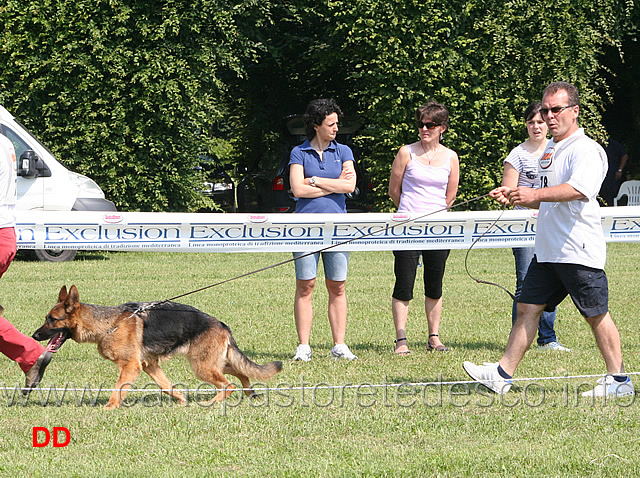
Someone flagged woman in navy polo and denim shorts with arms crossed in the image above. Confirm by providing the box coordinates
[289,99,358,362]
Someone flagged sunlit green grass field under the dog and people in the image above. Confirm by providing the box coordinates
[0,244,640,477]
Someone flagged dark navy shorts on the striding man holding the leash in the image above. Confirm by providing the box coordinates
[518,256,609,318]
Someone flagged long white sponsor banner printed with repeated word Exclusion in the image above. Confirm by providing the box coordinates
[16,206,640,252]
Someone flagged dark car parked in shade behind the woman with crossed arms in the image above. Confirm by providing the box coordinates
[237,115,371,212]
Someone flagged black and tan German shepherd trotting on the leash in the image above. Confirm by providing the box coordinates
[33,285,282,409]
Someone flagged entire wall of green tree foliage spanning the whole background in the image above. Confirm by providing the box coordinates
[0,0,638,210]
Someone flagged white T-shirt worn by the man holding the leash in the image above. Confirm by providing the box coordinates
[536,128,608,269]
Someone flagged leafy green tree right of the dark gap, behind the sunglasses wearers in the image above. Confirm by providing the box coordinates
[322,0,616,211]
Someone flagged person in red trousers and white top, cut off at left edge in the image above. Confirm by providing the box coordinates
[0,134,53,395]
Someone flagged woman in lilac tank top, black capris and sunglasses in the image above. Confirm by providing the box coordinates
[389,101,460,355]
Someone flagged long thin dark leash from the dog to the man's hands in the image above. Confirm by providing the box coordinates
[129,189,515,317]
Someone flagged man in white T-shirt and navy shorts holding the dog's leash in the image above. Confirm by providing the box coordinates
[463,82,635,397]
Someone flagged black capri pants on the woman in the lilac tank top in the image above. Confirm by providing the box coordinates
[392,250,449,301]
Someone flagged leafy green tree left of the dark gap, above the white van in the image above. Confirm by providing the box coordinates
[0,0,251,210]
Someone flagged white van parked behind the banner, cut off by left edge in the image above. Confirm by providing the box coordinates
[0,105,116,262]
